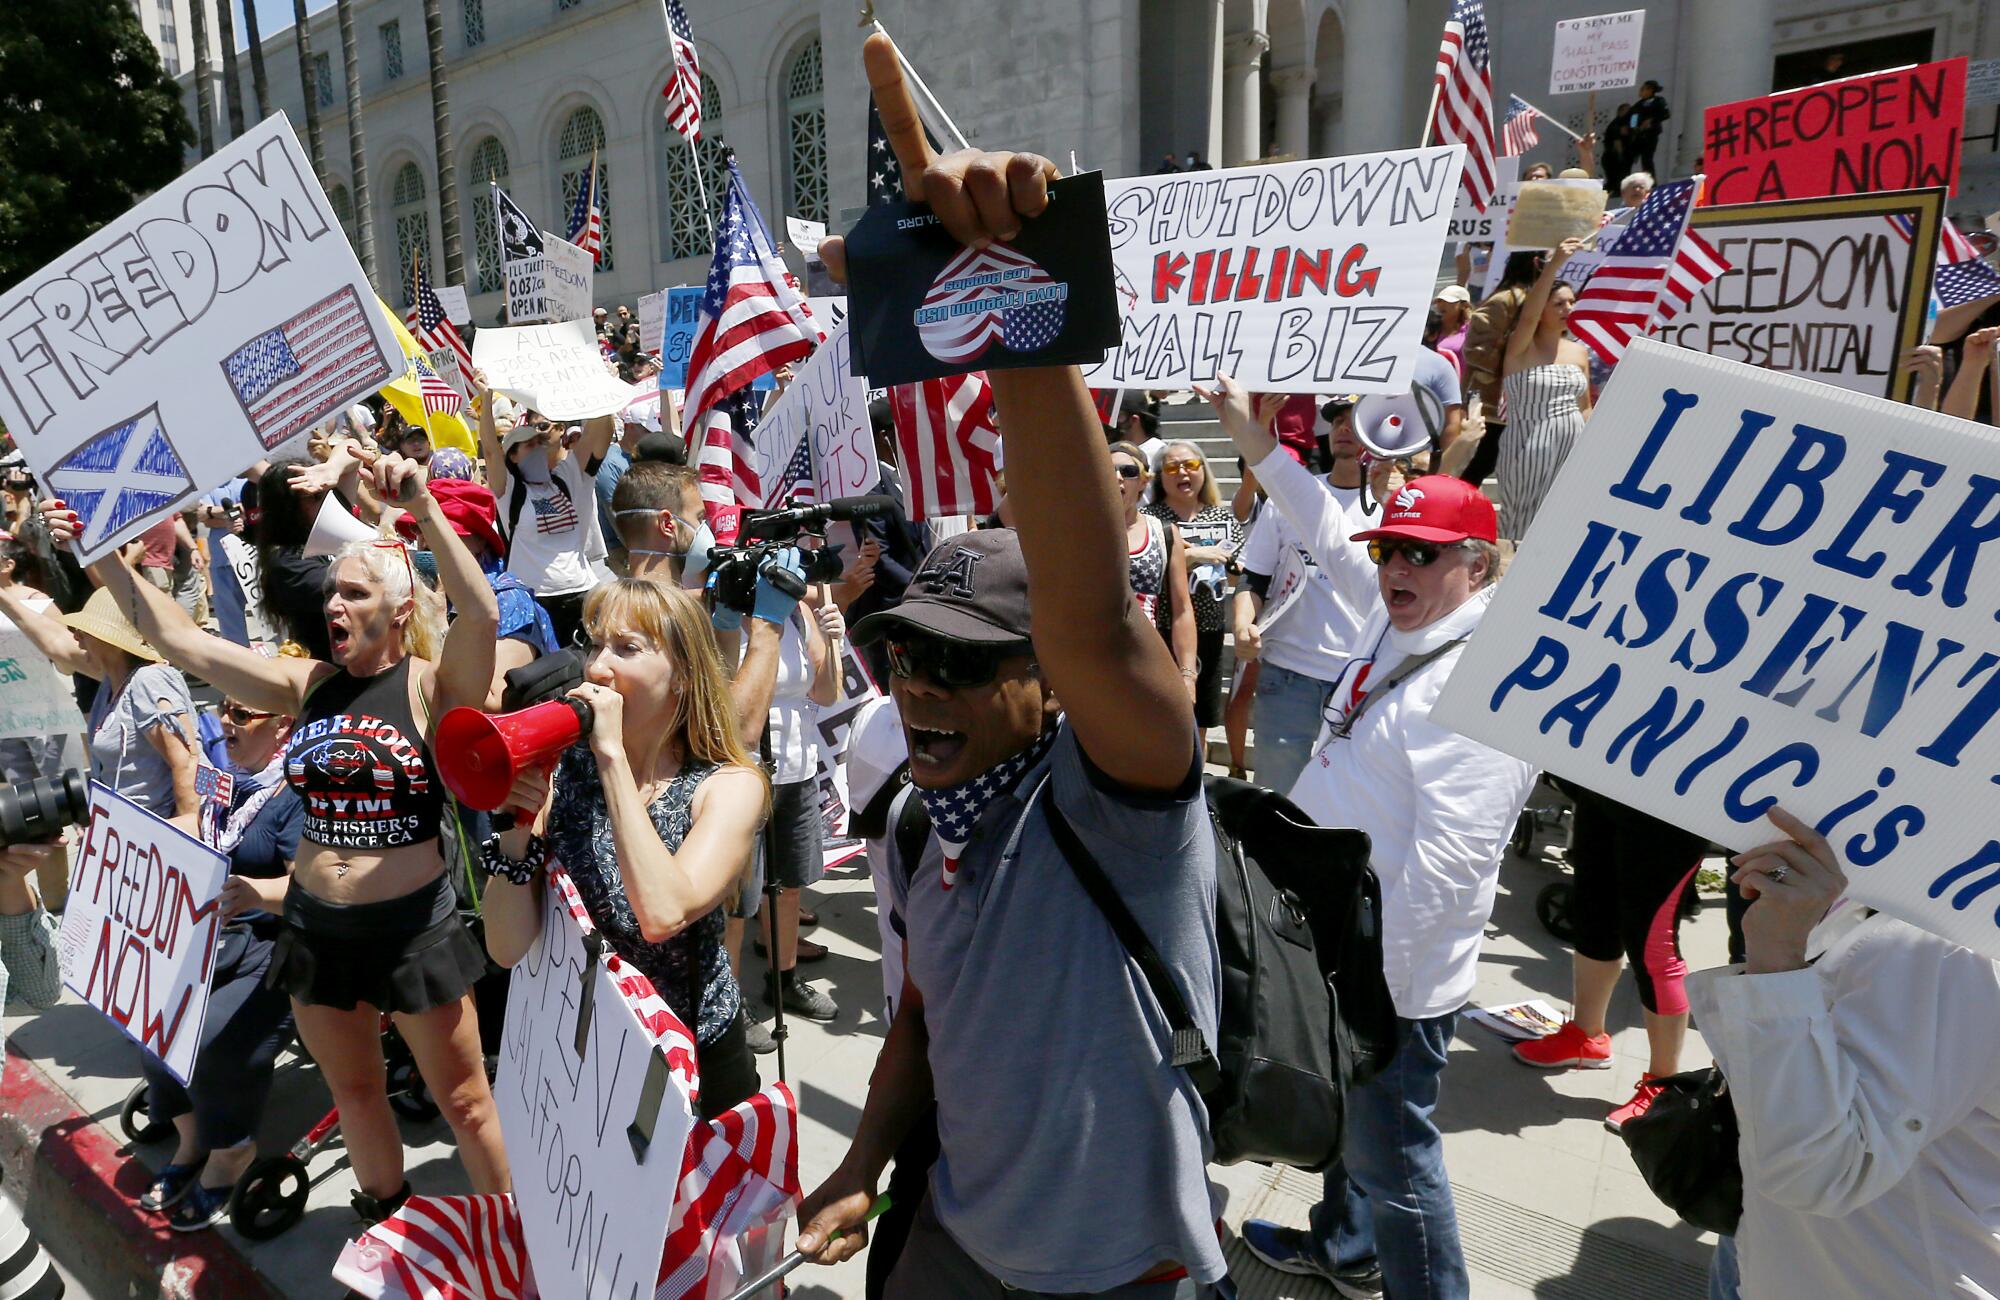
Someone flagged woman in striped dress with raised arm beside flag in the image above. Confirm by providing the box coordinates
[1498,240,1590,542]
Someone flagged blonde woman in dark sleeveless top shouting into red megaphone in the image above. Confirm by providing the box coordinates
[482,578,770,1118]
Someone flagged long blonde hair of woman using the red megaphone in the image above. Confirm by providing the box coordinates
[584,578,770,798]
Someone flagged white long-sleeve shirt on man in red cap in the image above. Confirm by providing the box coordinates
[1256,452,1536,1020]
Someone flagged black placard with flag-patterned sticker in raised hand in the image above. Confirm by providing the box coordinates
[848,172,1118,388]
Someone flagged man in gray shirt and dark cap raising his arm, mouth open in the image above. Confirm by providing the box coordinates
[798,34,1226,1300]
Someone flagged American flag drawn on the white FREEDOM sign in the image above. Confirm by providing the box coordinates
[222,288,398,450]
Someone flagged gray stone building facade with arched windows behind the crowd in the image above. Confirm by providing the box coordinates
[176,0,2000,324]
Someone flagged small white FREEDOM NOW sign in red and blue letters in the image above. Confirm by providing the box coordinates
[60,782,230,1084]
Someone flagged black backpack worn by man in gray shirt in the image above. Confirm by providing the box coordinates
[1042,776,1396,1170]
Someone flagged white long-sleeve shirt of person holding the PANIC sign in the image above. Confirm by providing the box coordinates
[1688,912,2000,1300]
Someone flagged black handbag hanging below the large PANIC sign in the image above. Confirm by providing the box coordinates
[1618,1066,1744,1236]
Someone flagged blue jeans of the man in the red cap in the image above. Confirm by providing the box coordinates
[1312,1012,1472,1300]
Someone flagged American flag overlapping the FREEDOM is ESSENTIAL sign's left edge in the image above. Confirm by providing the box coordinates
[1570,176,1730,366]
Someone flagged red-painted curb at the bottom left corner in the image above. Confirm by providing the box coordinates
[0,1046,282,1300]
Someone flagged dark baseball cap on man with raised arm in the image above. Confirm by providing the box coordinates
[850,528,1030,646]
